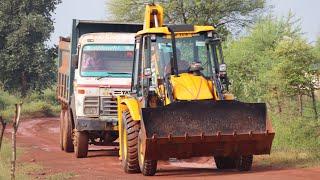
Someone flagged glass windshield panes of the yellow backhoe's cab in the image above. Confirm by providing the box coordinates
[151,34,222,77]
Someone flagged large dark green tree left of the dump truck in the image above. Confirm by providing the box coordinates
[0,0,60,96]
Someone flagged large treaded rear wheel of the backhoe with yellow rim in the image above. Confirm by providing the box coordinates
[120,111,140,173]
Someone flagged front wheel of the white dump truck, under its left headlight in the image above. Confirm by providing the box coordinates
[74,131,89,158]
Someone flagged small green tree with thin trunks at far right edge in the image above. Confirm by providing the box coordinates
[275,38,318,118]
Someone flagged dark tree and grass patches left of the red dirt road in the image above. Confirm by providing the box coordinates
[0,0,61,180]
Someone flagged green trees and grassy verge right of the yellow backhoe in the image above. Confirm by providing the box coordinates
[225,14,320,167]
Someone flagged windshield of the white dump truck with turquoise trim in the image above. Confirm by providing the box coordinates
[81,44,134,77]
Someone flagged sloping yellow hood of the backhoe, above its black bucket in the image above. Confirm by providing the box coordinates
[171,73,213,100]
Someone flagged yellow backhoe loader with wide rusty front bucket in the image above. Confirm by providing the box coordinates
[118,4,274,176]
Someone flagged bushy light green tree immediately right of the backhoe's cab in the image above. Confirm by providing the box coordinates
[225,15,300,104]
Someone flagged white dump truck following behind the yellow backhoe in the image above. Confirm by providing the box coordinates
[57,20,142,158]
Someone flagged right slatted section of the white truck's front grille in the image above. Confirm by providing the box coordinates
[100,96,118,117]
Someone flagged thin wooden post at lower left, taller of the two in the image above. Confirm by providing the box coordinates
[11,103,22,180]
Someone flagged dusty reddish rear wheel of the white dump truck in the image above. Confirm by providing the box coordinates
[62,110,74,152]
